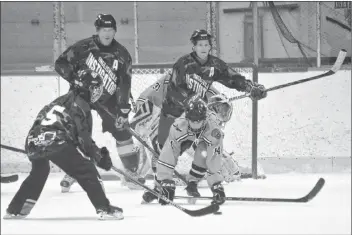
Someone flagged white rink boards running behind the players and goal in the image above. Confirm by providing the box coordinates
[1,70,351,173]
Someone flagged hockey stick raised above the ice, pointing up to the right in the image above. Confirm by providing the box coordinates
[228,49,347,102]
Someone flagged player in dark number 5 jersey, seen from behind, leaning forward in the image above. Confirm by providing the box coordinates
[4,75,123,219]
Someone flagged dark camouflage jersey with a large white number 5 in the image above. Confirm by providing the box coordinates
[25,91,98,159]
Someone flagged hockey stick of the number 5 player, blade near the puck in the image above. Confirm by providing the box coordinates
[112,166,220,216]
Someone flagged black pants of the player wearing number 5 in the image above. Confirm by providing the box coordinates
[8,144,110,215]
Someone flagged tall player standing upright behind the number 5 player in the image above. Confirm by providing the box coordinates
[55,14,139,190]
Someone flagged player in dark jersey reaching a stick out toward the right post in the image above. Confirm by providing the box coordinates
[158,30,267,151]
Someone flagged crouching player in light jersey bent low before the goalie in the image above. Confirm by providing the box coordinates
[156,95,225,205]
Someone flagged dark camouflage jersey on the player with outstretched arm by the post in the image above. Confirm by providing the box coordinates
[163,52,246,117]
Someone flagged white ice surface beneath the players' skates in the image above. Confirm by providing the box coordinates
[1,173,351,234]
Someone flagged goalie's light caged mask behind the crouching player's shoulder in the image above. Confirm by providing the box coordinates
[208,94,233,125]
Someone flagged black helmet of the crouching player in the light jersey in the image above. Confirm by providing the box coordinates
[185,95,207,121]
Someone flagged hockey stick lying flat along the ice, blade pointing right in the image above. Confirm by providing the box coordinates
[175,178,325,203]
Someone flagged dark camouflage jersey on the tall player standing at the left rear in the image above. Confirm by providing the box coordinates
[55,35,132,134]
